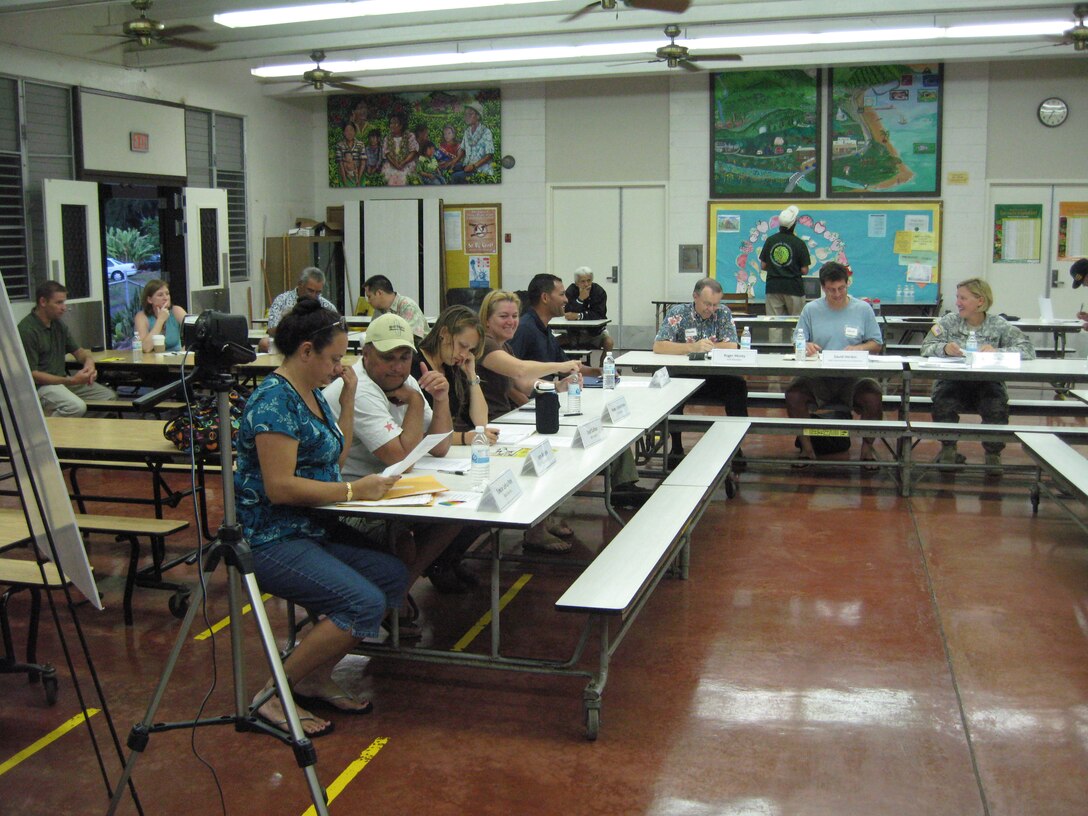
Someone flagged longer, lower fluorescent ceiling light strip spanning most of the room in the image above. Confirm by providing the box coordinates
[249,20,1070,79]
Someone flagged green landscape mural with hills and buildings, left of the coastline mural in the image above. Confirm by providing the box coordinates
[710,70,819,198]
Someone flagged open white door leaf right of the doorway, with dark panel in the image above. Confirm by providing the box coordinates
[184,187,231,313]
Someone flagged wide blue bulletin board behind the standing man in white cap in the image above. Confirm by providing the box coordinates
[707,200,941,304]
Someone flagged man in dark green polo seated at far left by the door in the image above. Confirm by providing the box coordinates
[18,281,118,417]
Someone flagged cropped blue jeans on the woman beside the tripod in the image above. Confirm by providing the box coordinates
[254,539,408,640]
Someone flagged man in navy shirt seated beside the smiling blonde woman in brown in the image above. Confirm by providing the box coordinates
[510,273,652,507]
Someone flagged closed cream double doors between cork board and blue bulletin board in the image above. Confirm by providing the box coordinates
[548,185,666,347]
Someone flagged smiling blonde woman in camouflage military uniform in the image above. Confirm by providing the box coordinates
[922,277,1035,475]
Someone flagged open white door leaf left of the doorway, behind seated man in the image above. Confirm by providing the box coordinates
[41,178,106,348]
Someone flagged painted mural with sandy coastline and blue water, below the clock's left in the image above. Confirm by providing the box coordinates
[828,64,941,196]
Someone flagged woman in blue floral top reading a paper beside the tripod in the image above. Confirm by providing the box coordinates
[234,298,407,738]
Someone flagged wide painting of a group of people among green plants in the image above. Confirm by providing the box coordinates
[327,88,503,187]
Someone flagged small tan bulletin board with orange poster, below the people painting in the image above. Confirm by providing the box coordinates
[442,202,503,290]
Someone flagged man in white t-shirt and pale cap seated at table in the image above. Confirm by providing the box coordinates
[324,313,475,592]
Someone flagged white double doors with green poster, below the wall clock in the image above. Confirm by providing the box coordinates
[987,183,1088,318]
